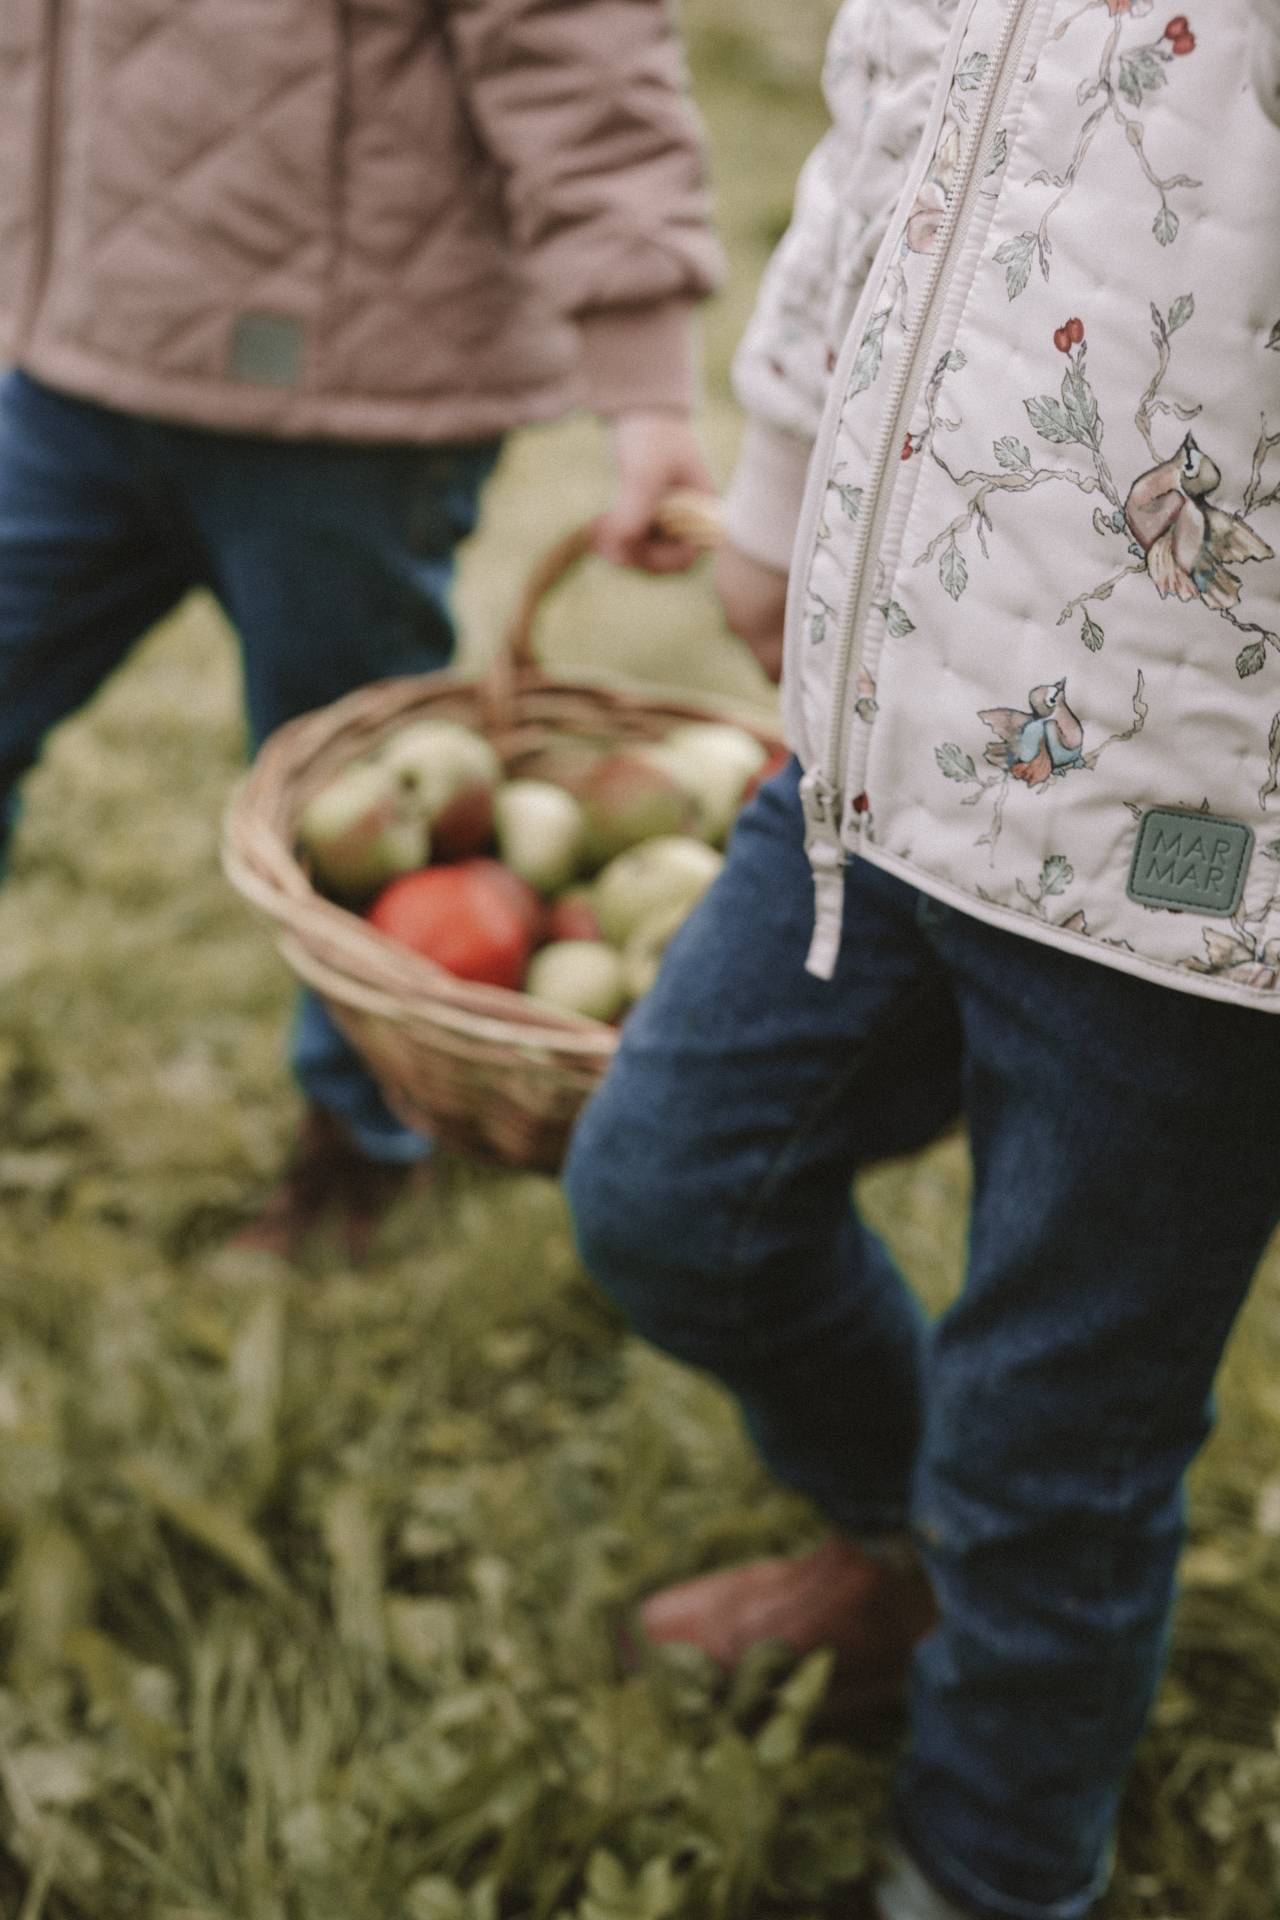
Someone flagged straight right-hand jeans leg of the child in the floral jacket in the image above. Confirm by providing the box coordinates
[896,914,1280,1920]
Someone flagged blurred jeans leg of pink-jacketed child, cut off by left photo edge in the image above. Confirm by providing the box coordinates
[0,372,190,858]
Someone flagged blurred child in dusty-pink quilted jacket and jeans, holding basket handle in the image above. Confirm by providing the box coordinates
[0,0,718,1252]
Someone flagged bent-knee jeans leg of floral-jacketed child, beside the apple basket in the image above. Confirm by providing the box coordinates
[566,764,960,1534]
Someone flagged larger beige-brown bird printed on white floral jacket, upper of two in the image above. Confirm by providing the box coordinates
[1125,434,1276,612]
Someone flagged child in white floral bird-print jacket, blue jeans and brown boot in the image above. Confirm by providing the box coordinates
[568,0,1280,1920]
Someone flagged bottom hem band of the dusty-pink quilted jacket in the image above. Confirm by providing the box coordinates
[15,342,583,445]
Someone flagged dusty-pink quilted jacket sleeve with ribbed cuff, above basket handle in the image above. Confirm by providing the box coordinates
[443,0,722,411]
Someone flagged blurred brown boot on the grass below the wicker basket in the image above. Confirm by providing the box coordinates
[230,1106,430,1265]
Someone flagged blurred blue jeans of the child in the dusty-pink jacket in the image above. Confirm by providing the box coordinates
[0,372,499,1162]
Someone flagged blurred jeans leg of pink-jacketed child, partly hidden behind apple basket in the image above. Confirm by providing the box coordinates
[171,428,499,1164]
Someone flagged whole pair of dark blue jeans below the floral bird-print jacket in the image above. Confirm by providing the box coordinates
[568,764,1280,1920]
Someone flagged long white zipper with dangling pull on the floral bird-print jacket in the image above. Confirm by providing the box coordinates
[800,0,1038,979]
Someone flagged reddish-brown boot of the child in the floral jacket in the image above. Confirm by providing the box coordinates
[639,1534,936,1718]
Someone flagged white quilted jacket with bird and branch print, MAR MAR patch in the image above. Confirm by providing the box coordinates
[737,0,1280,1012]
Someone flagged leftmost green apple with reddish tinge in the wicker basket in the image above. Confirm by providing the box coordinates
[297,760,430,900]
